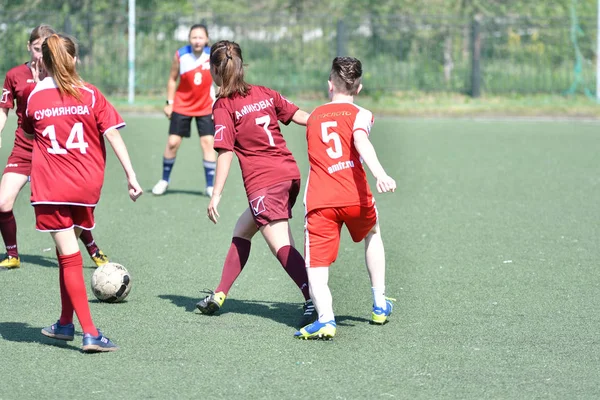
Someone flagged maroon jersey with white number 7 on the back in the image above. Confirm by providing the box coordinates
[213,85,300,195]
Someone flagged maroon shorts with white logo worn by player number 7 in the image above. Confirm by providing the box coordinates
[248,179,300,228]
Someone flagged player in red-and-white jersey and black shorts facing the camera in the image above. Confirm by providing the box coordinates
[152,24,216,197]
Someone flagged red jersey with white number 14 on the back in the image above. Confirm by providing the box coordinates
[22,78,125,206]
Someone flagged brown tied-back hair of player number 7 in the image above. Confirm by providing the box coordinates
[210,40,250,97]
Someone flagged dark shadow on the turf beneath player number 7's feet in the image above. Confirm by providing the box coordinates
[158,295,302,328]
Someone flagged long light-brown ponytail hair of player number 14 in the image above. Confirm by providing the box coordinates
[42,33,84,100]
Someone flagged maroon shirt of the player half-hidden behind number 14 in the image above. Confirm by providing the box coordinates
[0,64,35,152]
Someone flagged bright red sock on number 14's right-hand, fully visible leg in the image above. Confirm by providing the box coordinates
[58,251,98,336]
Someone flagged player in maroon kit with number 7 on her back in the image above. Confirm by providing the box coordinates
[197,41,314,324]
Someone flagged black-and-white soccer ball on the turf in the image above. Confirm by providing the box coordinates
[92,262,131,303]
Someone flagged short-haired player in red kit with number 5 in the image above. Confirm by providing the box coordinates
[295,57,396,339]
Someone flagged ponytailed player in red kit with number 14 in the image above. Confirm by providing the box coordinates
[22,34,142,352]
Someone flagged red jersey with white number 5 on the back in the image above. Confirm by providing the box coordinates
[304,102,373,213]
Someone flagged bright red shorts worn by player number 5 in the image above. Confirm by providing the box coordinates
[304,205,377,267]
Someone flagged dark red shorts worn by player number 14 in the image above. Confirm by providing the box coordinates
[33,204,95,232]
